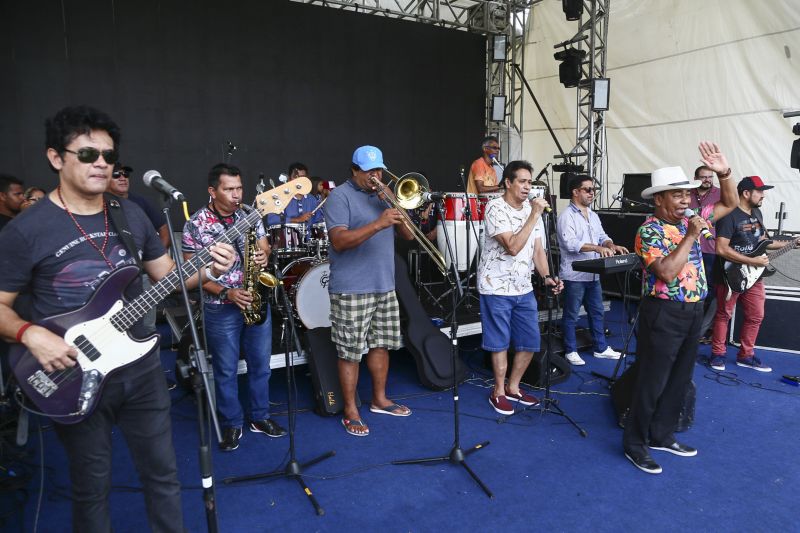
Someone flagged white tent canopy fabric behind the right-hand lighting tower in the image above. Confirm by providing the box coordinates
[523,0,800,231]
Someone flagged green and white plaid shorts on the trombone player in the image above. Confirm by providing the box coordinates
[330,291,402,363]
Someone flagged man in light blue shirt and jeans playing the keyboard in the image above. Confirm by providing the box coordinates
[558,174,628,365]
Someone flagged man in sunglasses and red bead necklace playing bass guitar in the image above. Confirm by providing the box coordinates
[0,106,235,531]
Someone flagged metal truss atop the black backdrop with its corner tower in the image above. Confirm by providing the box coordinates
[292,0,542,141]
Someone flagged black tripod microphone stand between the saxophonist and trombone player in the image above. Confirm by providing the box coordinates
[222,273,336,516]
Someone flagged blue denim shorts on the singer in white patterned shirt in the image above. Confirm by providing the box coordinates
[480,291,541,352]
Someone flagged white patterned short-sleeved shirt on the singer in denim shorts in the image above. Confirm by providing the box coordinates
[478,197,544,296]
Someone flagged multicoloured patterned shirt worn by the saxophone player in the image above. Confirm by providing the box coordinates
[182,206,266,304]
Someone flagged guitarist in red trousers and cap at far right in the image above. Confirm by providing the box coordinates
[711,176,796,372]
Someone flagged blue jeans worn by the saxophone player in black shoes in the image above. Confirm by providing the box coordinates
[204,304,272,427]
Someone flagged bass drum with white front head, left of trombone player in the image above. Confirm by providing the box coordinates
[281,257,331,329]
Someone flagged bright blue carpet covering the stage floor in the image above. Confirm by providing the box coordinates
[3,303,800,532]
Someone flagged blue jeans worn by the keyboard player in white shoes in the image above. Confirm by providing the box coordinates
[561,280,608,353]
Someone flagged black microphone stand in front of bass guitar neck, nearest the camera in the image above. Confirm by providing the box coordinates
[163,201,222,533]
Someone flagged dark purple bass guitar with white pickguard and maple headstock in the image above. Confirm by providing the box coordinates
[9,178,311,424]
